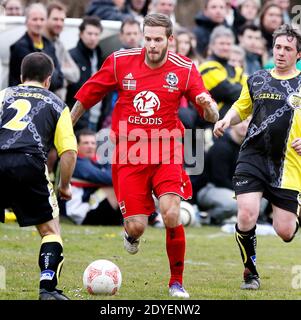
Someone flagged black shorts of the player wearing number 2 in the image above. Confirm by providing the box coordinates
[0,153,59,227]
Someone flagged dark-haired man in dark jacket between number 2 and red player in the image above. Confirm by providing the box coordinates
[66,16,103,132]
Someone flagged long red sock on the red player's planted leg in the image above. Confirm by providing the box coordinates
[166,225,186,286]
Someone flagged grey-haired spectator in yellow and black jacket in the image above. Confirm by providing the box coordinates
[199,26,245,117]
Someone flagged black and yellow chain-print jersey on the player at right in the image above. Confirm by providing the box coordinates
[232,70,301,192]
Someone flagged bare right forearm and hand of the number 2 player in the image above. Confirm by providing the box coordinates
[59,150,77,200]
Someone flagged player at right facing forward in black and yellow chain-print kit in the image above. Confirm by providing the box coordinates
[214,25,301,290]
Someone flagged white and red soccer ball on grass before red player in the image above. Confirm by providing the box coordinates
[83,259,122,295]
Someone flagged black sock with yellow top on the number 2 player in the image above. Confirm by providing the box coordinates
[39,235,64,291]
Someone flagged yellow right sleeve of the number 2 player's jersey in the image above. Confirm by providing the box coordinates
[54,107,77,156]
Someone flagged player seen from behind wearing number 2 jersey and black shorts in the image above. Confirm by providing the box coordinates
[0,52,77,300]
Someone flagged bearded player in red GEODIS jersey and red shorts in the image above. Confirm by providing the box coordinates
[71,14,218,298]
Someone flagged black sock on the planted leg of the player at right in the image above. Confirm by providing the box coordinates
[235,224,258,276]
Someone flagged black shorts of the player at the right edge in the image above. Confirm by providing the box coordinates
[233,174,301,215]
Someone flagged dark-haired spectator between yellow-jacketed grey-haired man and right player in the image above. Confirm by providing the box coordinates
[238,24,263,75]
